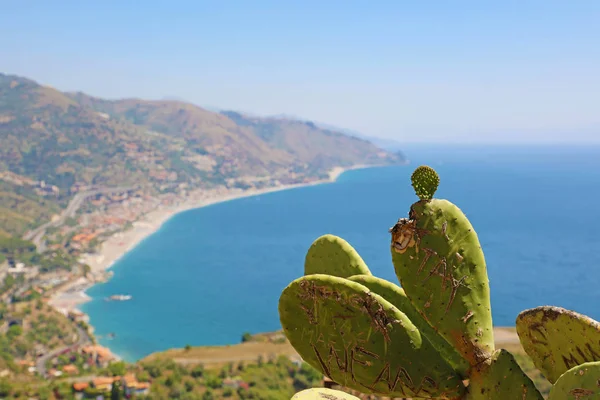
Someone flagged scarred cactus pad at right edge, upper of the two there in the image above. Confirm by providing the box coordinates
[517,306,600,383]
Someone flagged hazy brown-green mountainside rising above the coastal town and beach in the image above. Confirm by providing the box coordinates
[0,74,404,235]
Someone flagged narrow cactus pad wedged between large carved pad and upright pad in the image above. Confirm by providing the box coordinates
[348,275,470,377]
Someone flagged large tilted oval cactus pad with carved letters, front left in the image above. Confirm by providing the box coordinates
[279,274,465,399]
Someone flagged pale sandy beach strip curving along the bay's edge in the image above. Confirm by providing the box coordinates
[48,165,381,333]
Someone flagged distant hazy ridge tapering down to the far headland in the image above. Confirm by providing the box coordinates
[70,93,403,176]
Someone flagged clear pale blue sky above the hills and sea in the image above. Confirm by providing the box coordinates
[0,0,600,144]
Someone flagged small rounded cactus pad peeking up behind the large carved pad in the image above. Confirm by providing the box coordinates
[304,235,371,278]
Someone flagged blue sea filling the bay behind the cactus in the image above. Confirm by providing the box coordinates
[83,146,600,361]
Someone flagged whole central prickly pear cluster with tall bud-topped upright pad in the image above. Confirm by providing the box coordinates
[279,167,542,400]
